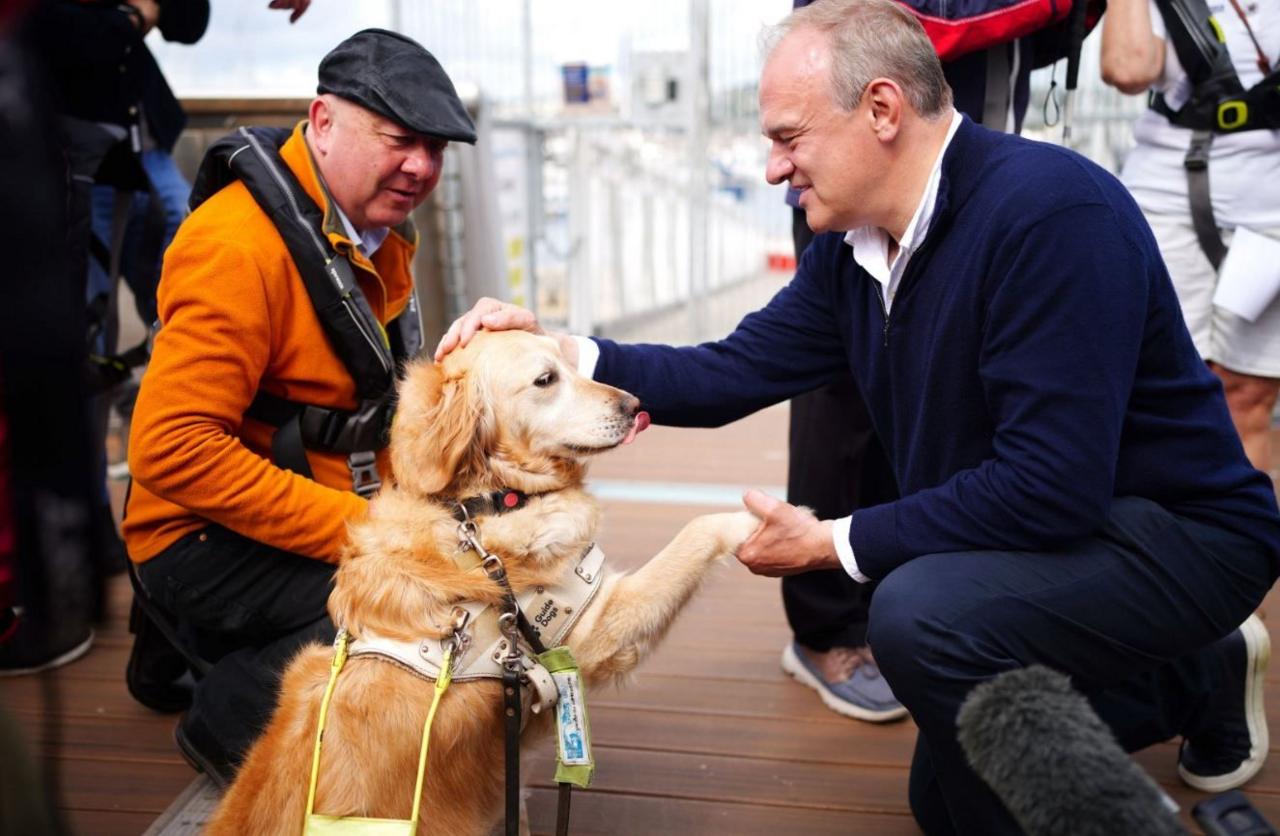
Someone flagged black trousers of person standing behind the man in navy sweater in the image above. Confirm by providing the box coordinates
[782,207,897,650]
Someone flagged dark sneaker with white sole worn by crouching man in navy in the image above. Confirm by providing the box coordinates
[1178,616,1271,792]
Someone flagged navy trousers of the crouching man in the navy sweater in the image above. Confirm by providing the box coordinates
[869,498,1276,836]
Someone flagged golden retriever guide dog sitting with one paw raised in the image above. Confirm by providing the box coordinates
[207,332,758,836]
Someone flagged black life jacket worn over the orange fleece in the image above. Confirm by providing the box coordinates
[191,127,422,497]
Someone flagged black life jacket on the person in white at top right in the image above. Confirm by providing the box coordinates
[1151,0,1280,133]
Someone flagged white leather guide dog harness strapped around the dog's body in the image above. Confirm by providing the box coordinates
[348,543,604,712]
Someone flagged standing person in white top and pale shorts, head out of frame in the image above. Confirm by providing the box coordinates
[1102,0,1280,474]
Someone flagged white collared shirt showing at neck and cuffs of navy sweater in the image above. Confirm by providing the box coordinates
[575,110,963,584]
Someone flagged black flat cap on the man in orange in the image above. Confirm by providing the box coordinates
[317,29,476,145]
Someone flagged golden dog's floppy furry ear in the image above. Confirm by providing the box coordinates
[390,360,488,495]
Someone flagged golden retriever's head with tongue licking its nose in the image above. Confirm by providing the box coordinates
[390,330,640,495]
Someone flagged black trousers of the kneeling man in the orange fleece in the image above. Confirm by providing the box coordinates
[138,525,335,762]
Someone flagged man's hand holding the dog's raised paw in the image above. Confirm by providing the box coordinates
[737,490,841,577]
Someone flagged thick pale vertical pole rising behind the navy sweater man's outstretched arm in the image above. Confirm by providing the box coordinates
[689,0,710,342]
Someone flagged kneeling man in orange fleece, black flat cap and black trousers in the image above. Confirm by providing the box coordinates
[123,29,475,782]
